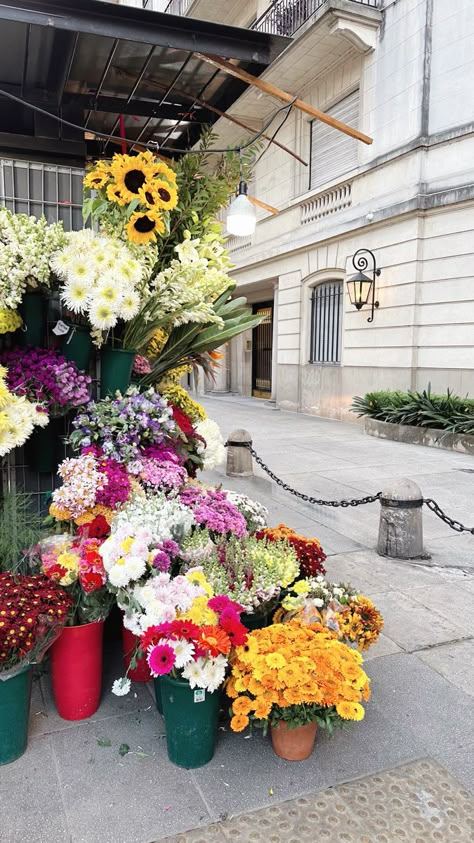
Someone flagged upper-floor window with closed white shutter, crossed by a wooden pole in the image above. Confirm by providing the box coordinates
[309,91,359,190]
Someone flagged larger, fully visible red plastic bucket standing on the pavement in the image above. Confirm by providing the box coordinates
[51,621,104,720]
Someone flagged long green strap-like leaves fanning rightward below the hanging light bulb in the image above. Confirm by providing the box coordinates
[141,286,262,386]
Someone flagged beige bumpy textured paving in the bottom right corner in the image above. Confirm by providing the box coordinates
[163,759,472,843]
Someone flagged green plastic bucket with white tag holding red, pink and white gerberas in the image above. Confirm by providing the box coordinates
[160,676,221,770]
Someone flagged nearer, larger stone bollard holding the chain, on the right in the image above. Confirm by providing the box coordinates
[377,480,426,559]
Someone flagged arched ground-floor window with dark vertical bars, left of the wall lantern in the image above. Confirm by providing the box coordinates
[309,281,343,363]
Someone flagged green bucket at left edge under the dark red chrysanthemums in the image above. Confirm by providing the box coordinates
[0,667,32,764]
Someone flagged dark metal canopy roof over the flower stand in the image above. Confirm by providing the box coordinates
[0,0,290,163]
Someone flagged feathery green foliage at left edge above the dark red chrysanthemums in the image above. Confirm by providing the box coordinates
[0,492,43,574]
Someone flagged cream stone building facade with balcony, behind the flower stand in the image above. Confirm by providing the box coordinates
[160,0,474,419]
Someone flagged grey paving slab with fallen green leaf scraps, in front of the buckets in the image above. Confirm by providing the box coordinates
[50,711,212,843]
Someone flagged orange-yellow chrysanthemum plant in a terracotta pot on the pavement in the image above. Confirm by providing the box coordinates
[226,621,370,761]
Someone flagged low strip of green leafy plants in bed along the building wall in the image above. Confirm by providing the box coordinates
[351,384,474,435]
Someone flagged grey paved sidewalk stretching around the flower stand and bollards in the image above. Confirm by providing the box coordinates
[0,397,474,843]
